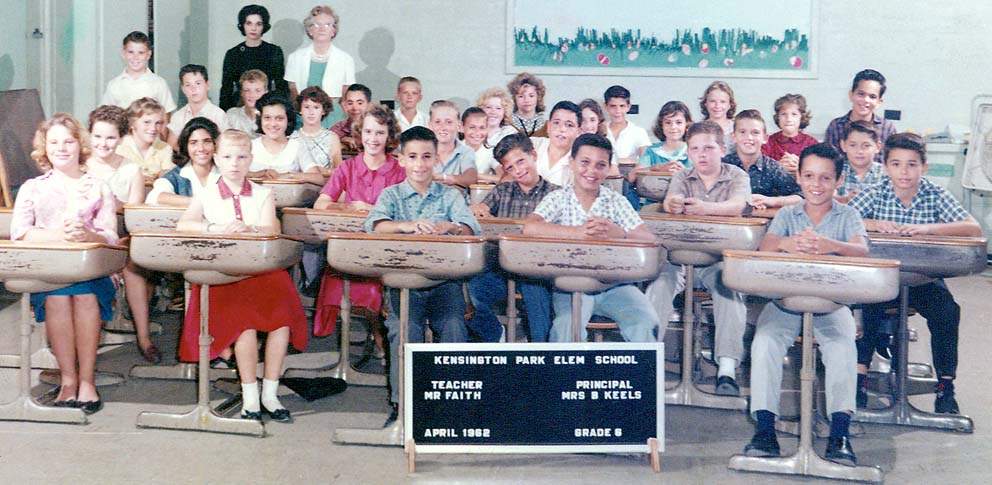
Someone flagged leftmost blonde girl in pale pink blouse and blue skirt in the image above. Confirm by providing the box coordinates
[10,113,117,414]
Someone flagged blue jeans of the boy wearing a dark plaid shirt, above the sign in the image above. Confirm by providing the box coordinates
[468,271,551,342]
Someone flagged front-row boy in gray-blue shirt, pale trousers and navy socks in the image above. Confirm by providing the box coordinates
[744,143,868,466]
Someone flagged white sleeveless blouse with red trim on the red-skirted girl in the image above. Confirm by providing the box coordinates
[202,178,275,226]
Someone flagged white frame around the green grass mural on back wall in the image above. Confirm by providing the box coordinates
[506,0,820,79]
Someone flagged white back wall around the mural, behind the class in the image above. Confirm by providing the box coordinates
[198,0,992,134]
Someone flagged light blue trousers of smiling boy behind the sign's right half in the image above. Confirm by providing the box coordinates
[551,285,665,342]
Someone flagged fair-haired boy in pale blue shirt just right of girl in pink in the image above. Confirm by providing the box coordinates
[428,100,478,190]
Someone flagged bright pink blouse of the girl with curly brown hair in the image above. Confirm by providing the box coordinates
[320,153,406,204]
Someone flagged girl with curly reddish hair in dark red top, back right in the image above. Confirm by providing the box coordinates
[761,94,817,172]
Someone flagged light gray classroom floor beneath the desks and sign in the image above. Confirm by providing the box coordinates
[0,275,992,484]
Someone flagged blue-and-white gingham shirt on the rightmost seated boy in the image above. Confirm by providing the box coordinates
[848,177,970,224]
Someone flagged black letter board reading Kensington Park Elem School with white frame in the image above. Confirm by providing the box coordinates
[404,342,665,453]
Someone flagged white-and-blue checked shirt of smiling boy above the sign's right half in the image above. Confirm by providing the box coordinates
[534,185,644,231]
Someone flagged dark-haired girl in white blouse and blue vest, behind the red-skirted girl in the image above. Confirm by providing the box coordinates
[145,118,220,207]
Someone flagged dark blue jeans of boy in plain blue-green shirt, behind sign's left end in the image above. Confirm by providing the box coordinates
[386,281,467,402]
